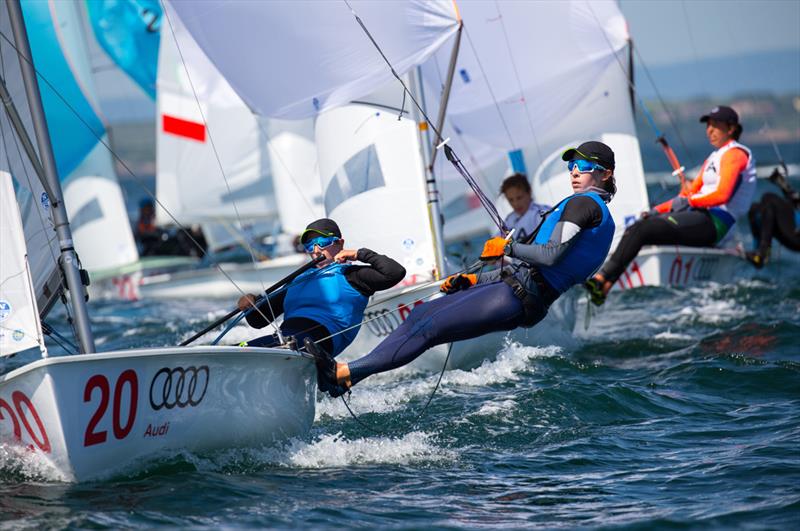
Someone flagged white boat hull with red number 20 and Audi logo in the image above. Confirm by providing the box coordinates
[0,347,316,481]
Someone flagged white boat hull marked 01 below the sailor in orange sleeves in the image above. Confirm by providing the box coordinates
[614,246,742,290]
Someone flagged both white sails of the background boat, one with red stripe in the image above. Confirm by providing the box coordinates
[157,4,322,239]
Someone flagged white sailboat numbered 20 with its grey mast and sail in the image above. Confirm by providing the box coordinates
[0,1,316,481]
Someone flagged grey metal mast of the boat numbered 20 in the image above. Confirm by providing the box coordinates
[7,0,96,354]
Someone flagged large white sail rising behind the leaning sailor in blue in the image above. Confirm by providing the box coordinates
[422,0,647,241]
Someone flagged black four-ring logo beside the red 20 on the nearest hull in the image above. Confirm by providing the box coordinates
[150,365,209,411]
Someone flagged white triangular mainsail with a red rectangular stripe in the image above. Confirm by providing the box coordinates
[156,1,277,224]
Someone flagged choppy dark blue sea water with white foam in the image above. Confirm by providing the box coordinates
[0,180,800,529]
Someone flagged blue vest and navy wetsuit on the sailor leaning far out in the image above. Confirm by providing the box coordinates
[348,192,614,384]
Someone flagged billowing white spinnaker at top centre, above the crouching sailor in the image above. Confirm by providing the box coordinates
[171,0,458,119]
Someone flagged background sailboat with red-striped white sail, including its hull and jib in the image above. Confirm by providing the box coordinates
[140,5,322,297]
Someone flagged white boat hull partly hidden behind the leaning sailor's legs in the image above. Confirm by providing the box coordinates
[341,283,577,371]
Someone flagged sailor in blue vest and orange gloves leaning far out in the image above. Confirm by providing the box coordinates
[309,142,616,396]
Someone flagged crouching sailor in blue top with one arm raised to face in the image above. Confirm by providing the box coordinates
[238,218,406,388]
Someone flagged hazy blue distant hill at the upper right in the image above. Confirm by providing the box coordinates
[635,49,800,100]
